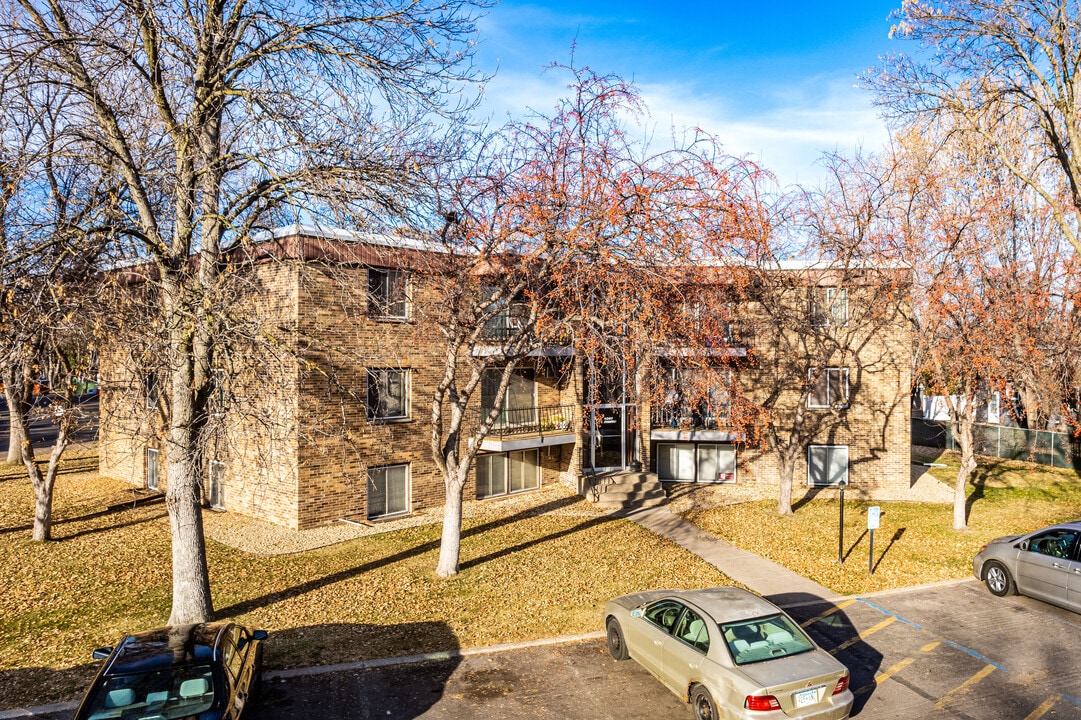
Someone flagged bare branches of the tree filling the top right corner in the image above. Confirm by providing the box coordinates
[864,0,1081,252]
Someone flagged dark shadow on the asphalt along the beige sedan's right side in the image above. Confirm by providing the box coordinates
[785,592,882,716]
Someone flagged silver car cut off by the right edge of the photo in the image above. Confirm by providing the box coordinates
[972,521,1081,612]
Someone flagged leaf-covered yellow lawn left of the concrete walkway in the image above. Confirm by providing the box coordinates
[0,464,730,709]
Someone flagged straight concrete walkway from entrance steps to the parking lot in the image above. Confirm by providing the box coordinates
[613,505,841,608]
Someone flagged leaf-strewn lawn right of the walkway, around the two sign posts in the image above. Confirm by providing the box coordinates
[685,453,1081,595]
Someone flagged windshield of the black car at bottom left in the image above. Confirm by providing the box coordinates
[82,664,214,720]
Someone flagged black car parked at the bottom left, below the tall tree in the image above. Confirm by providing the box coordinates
[75,623,267,720]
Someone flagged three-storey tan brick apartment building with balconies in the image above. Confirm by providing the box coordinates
[99,226,911,530]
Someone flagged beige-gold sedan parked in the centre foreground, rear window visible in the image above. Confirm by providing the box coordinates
[604,587,853,720]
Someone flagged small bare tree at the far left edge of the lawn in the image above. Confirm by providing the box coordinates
[0,68,115,541]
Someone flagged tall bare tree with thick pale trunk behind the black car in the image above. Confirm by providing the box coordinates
[2,0,486,624]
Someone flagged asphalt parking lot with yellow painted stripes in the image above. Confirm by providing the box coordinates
[238,581,1081,720]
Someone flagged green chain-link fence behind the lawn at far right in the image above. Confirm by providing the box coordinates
[912,417,1081,470]
